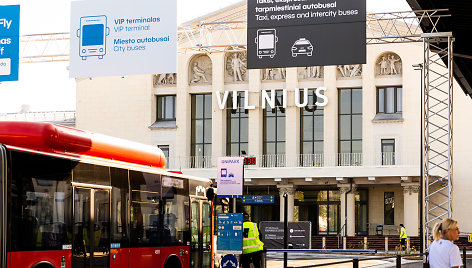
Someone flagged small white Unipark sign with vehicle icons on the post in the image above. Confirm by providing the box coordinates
[217,157,244,198]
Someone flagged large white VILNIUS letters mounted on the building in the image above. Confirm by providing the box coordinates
[216,87,328,110]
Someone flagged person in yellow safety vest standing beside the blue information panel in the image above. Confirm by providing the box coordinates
[241,213,264,268]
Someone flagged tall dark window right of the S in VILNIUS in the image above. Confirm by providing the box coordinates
[337,88,362,166]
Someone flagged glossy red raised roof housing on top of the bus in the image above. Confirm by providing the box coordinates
[0,121,166,169]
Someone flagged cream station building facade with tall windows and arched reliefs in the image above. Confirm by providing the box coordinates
[76,2,472,236]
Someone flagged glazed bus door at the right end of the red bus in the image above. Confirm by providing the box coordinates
[190,197,212,268]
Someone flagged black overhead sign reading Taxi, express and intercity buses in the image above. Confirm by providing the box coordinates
[247,0,366,69]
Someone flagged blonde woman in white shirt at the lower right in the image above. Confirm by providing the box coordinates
[428,218,462,268]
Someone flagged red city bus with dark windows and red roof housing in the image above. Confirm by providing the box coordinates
[0,122,212,268]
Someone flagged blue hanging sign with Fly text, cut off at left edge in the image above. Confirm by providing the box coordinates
[0,5,20,81]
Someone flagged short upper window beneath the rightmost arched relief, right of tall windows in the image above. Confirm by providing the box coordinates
[377,87,403,114]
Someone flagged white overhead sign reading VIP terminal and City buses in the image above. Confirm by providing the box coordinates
[70,0,177,77]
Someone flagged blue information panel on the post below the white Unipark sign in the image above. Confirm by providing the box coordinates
[216,213,243,254]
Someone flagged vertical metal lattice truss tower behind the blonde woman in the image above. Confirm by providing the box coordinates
[422,32,454,250]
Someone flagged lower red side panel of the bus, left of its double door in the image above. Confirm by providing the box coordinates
[8,250,72,268]
